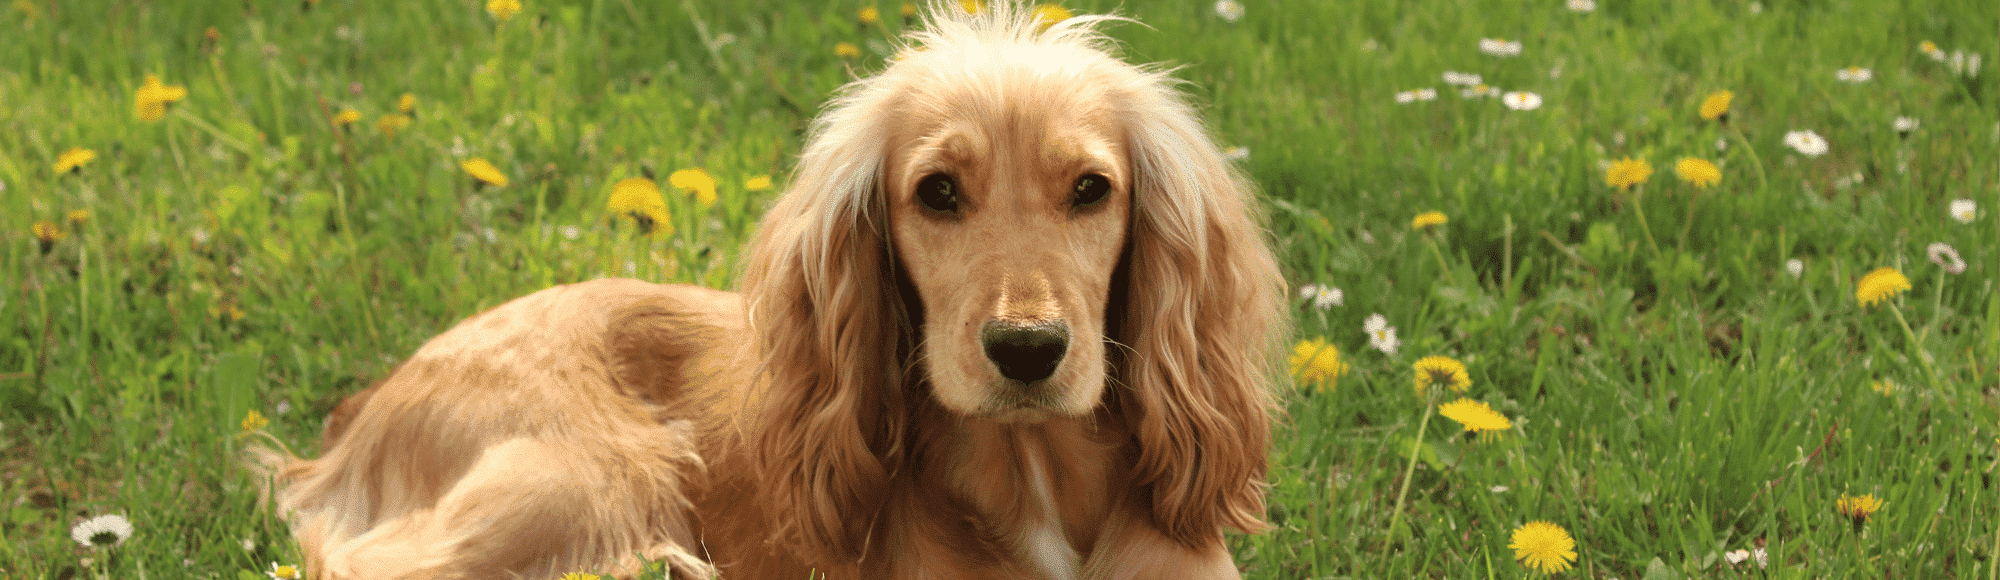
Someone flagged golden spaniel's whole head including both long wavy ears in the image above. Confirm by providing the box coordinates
[744,2,1284,556]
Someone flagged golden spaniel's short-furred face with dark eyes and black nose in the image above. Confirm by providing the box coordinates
[884,62,1132,422]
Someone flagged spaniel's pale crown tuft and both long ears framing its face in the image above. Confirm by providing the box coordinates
[742,2,1284,562]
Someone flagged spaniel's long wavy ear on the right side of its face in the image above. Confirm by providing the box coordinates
[1116,72,1284,548]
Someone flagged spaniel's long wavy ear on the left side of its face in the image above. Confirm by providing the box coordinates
[744,80,910,562]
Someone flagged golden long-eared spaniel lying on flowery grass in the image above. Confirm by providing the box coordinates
[254,2,1288,580]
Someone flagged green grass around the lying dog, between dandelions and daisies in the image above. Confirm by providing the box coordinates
[0,0,2000,580]
